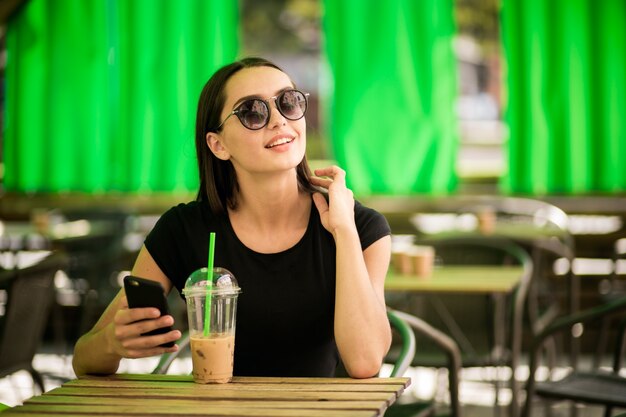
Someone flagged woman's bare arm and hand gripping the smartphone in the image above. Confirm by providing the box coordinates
[72,247,181,377]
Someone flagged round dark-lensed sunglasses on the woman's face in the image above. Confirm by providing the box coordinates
[215,90,309,132]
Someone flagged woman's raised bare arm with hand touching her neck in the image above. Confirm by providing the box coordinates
[312,167,391,378]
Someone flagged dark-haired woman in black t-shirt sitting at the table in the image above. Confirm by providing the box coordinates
[73,58,391,378]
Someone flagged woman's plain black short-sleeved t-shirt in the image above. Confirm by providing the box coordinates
[145,197,390,377]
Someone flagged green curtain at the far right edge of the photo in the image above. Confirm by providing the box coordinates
[502,0,626,194]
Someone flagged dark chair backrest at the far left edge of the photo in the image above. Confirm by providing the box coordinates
[0,252,67,377]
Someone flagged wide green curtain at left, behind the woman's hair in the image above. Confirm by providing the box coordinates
[4,0,239,193]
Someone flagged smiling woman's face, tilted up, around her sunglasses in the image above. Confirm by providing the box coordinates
[207,67,306,179]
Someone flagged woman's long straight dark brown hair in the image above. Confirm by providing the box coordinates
[196,57,317,214]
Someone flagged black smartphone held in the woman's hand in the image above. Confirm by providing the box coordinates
[124,275,174,347]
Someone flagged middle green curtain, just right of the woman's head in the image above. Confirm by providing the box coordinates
[323,0,458,195]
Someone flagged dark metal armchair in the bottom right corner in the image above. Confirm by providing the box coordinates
[522,297,626,417]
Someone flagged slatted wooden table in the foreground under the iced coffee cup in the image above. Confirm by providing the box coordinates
[3,374,410,417]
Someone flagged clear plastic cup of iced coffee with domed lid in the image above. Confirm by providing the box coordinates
[183,268,241,384]
